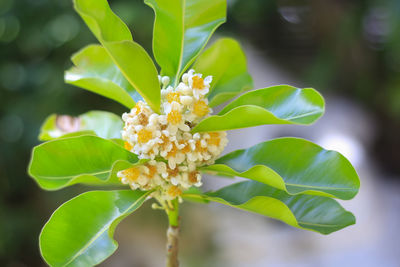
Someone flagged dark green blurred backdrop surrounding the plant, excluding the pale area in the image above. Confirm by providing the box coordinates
[0,0,400,266]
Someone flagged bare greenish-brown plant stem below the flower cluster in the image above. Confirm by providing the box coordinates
[166,199,179,267]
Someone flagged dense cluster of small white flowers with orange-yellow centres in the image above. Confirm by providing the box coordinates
[118,70,228,200]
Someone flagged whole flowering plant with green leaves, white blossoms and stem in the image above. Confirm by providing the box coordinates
[29,0,359,266]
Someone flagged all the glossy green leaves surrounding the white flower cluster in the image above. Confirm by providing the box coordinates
[29,0,359,266]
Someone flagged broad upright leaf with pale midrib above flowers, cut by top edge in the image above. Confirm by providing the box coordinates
[145,0,226,84]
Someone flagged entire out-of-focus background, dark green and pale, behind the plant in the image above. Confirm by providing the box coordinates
[0,0,400,267]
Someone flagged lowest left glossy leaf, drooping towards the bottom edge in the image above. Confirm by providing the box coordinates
[39,190,151,267]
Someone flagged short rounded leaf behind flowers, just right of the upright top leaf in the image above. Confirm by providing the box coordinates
[193,38,253,107]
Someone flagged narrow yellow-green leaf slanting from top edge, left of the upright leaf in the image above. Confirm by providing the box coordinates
[74,0,161,112]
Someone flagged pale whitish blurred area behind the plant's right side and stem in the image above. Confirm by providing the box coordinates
[102,43,400,267]
